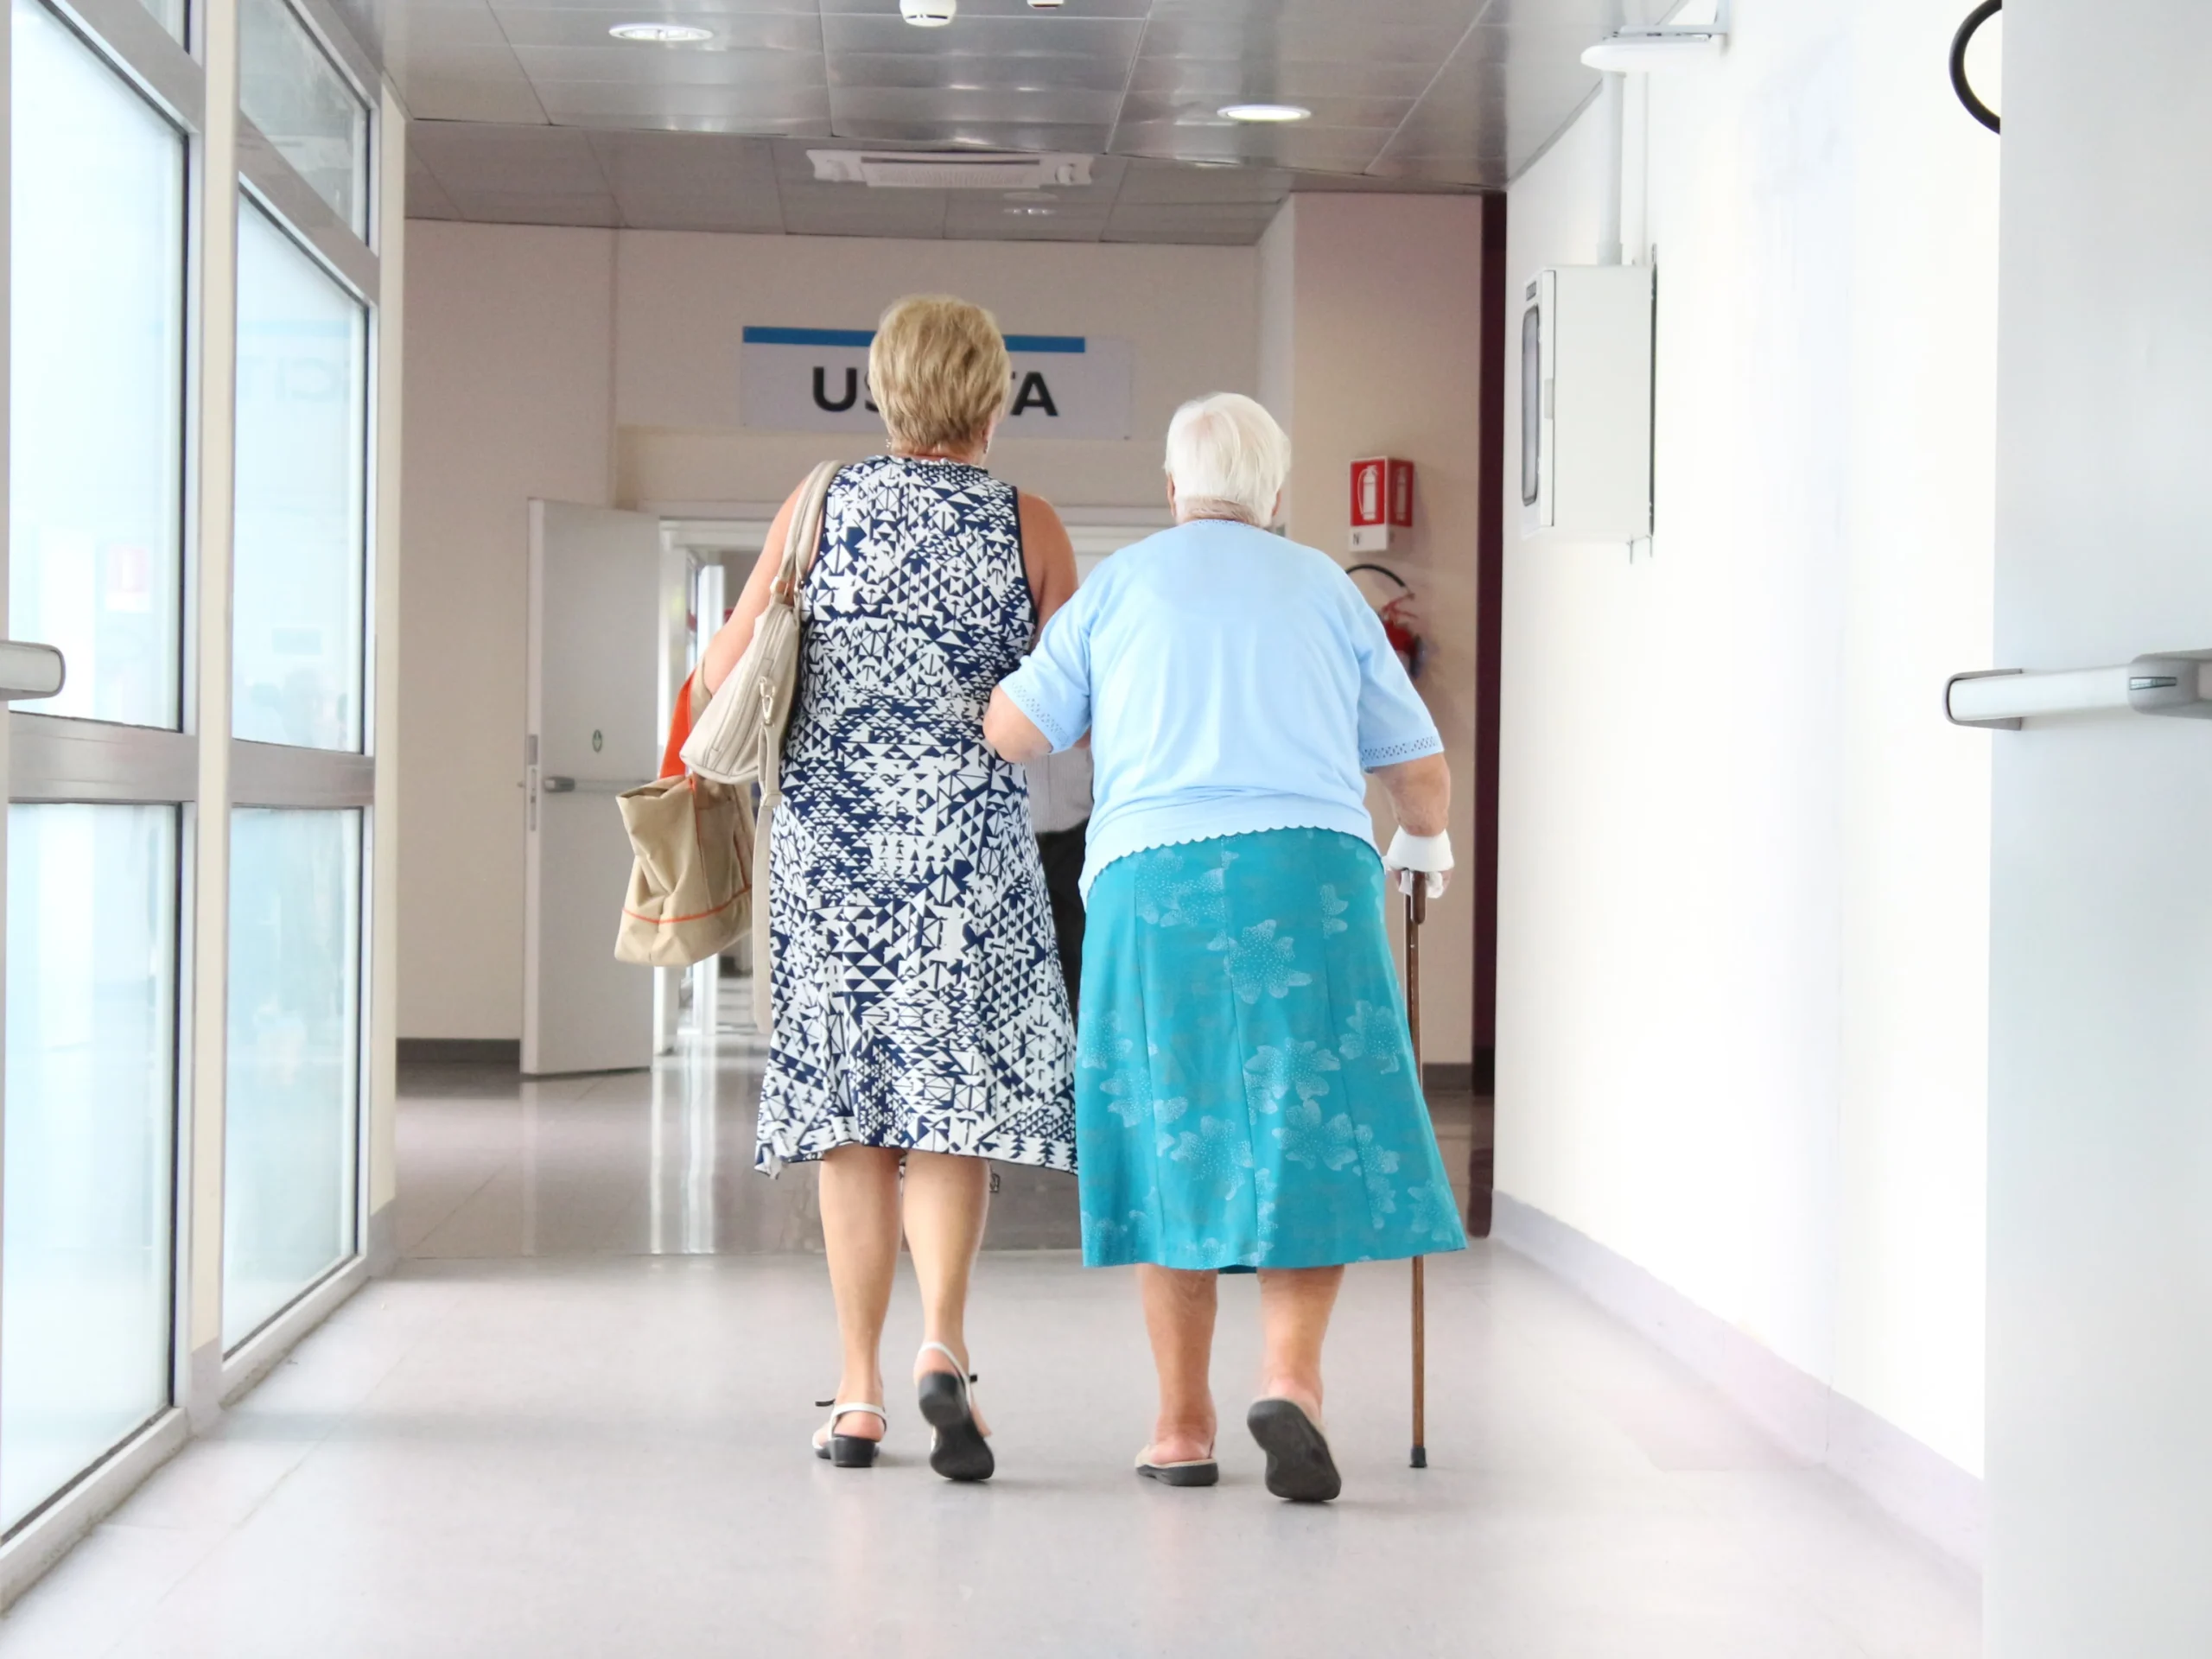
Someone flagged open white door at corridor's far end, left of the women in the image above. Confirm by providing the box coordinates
[522,502,661,1075]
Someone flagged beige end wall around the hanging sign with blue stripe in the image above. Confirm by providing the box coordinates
[400,221,1256,1038]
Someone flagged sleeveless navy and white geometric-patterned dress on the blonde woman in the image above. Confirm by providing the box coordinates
[754,455,1075,1170]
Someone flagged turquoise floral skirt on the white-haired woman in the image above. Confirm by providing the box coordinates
[1075,830,1466,1269]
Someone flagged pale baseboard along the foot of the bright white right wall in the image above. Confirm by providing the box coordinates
[1491,1192,1988,1573]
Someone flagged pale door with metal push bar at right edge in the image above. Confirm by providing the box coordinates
[1986,0,2212,1659]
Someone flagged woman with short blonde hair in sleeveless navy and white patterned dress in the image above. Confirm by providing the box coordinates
[702,296,1075,1480]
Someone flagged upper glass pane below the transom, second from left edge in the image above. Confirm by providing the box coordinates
[230,206,370,750]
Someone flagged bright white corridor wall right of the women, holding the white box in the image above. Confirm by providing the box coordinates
[1497,0,1998,1471]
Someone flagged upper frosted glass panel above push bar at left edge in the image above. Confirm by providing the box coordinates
[9,0,183,728]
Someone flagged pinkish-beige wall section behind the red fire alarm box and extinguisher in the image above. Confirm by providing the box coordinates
[1259,193,1482,1064]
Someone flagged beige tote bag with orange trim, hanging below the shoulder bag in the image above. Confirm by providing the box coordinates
[615,677,766,967]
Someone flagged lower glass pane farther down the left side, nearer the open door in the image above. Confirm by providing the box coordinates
[224,810,360,1351]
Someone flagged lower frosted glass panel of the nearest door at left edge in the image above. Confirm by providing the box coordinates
[0,805,177,1529]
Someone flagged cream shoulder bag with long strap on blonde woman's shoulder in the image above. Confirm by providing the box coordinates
[683,460,838,1033]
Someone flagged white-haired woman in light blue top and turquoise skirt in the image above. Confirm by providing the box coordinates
[984,394,1466,1502]
